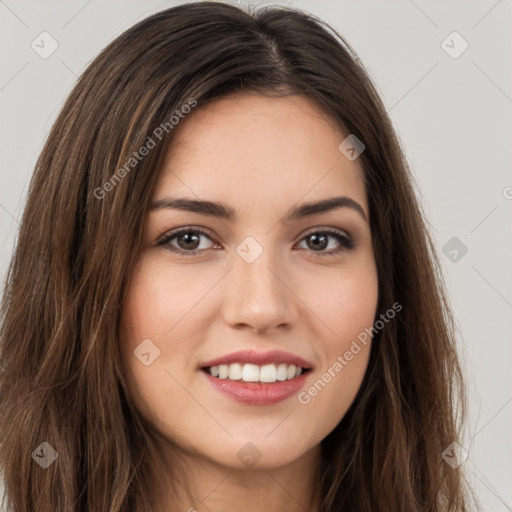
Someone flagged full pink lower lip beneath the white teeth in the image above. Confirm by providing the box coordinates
[200,370,310,405]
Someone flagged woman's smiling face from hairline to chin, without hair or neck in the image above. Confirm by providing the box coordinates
[121,94,378,468]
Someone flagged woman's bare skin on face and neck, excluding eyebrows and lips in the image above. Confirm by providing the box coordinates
[121,93,378,512]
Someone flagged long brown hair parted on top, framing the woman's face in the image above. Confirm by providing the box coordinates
[0,2,468,512]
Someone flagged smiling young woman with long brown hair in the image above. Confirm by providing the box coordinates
[0,2,468,512]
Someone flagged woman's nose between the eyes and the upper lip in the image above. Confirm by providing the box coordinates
[223,245,299,334]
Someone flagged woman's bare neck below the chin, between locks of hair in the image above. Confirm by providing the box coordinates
[149,438,321,512]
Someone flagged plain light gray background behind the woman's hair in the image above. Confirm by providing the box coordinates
[0,0,512,512]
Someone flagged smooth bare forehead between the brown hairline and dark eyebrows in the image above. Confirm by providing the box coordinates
[154,94,366,215]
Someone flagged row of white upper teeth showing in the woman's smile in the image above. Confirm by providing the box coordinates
[208,363,302,383]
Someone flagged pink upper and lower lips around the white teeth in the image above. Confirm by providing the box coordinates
[201,350,313,405]
